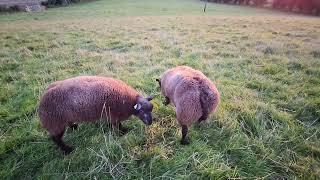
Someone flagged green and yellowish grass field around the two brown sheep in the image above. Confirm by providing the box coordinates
[0,0,320,179]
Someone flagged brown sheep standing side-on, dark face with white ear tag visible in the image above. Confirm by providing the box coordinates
[38,76,153,154]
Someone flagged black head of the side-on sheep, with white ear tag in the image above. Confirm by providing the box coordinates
[134,96,153,125]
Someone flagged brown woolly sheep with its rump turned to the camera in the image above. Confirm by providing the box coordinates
[156,66,220,145]
